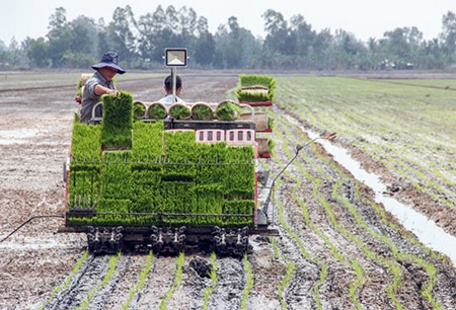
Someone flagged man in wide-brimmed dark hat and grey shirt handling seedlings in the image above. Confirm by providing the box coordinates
[79,52,126,123]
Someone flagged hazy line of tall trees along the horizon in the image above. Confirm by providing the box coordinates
[0,5,456,70]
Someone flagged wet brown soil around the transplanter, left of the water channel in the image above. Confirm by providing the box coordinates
[0,74,456,309]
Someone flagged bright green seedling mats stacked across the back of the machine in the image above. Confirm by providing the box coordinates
[67,93,256,225]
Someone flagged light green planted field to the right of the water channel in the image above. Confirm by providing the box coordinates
[272,79,456,216]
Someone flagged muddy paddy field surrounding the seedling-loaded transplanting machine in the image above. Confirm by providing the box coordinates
[0,70,456,309]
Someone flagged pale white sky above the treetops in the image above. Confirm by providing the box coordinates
[0,0,456,46]
